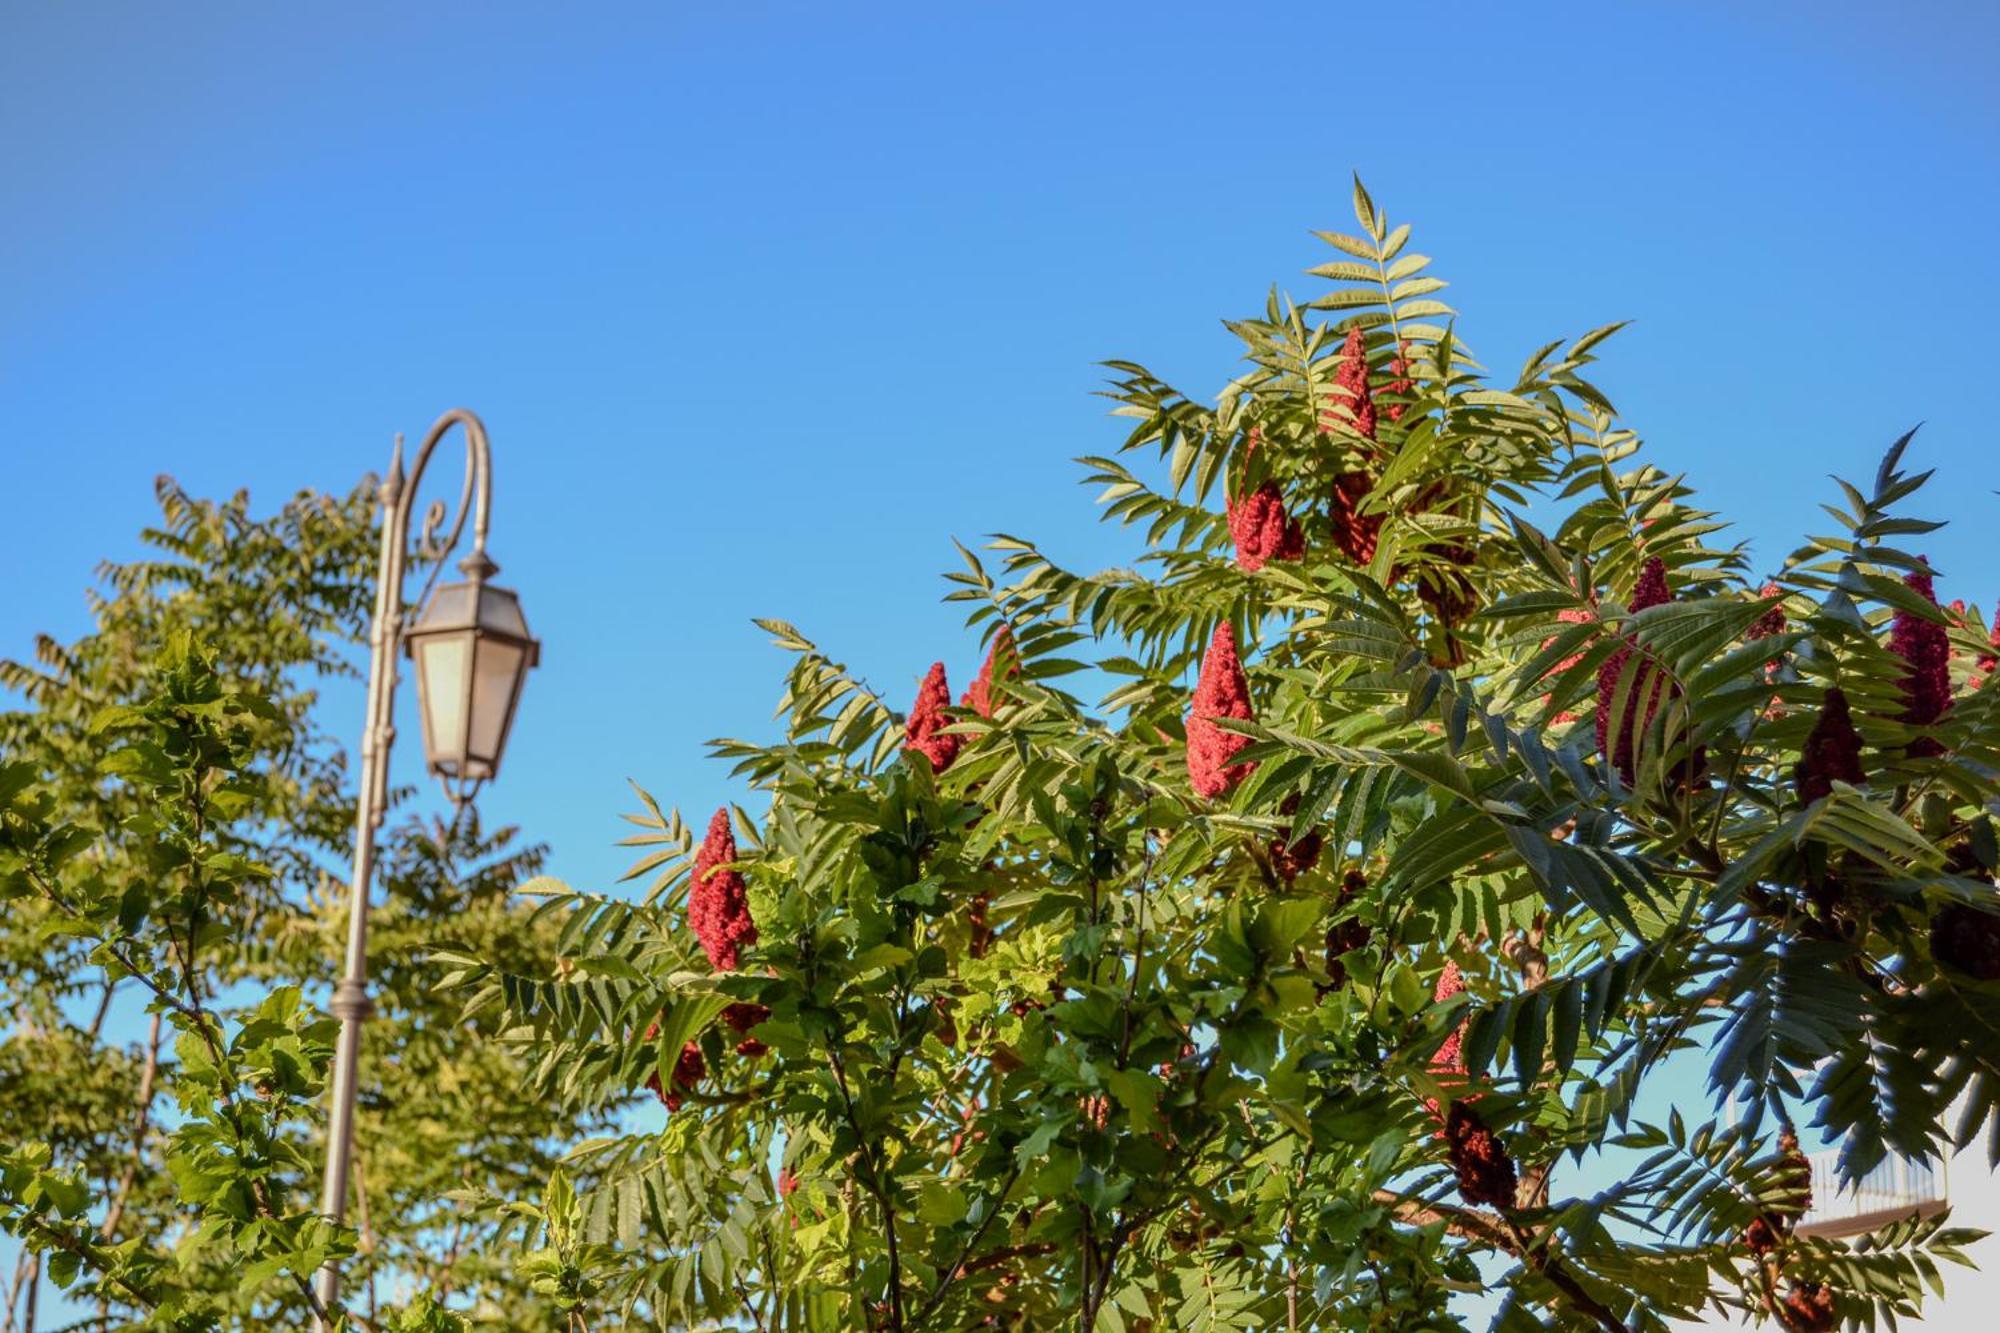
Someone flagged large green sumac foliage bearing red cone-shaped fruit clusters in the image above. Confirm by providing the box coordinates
[448,184,2000,1331]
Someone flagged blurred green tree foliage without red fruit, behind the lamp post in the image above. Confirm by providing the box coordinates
[0,480,596,1329]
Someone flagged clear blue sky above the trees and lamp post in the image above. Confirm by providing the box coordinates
[0,2,2000,1320]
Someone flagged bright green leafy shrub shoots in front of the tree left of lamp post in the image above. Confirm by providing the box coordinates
[0,632,350,1327]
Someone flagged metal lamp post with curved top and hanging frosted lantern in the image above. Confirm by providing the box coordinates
[318,408,542,1329]
